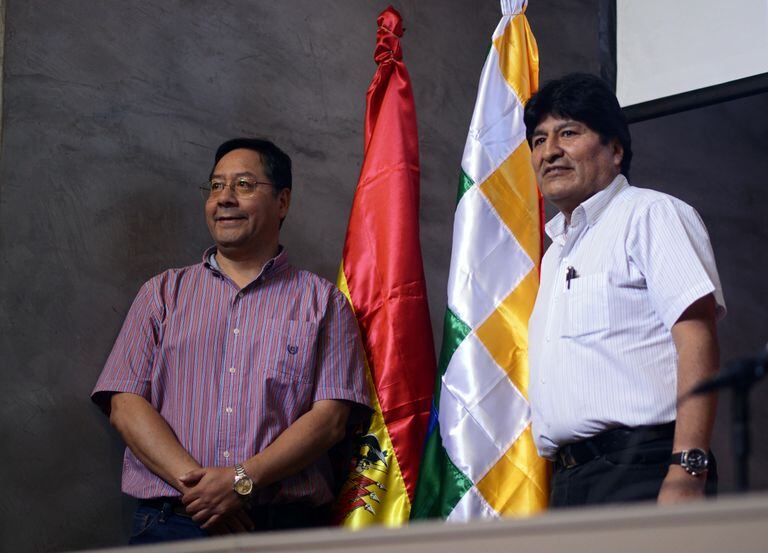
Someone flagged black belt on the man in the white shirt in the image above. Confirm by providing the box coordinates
[555,421,675,470]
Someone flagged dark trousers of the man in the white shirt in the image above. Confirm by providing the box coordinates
[550,427,717,508]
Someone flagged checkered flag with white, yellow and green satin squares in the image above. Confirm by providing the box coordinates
[411,0,548,520]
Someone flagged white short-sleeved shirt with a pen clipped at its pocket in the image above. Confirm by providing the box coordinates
[528,175,725,458]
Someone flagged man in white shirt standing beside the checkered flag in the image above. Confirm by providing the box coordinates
[525,74,725,507]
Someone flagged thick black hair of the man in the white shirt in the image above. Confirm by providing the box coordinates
[524,73,632,177]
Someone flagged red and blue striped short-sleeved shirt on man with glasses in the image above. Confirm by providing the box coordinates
[92,248,368,505]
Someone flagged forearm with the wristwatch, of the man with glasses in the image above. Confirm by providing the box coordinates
[243,400,350,488]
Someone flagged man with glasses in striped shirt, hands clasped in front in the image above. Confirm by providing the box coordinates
[92,138,368,543]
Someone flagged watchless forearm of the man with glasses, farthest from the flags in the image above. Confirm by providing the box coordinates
[109,393,200,493]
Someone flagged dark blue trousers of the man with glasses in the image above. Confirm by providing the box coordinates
[128,498,330,545]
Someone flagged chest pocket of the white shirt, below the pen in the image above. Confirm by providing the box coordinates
[560,272,609,338]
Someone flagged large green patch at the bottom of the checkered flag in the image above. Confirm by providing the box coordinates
[411,424,472,519]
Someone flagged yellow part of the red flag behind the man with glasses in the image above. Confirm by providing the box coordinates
[336,266,411,530]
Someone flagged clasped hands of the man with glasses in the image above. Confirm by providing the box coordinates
[179,467,253,532]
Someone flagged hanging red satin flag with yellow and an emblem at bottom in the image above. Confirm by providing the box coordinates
[336,6,435,528]
